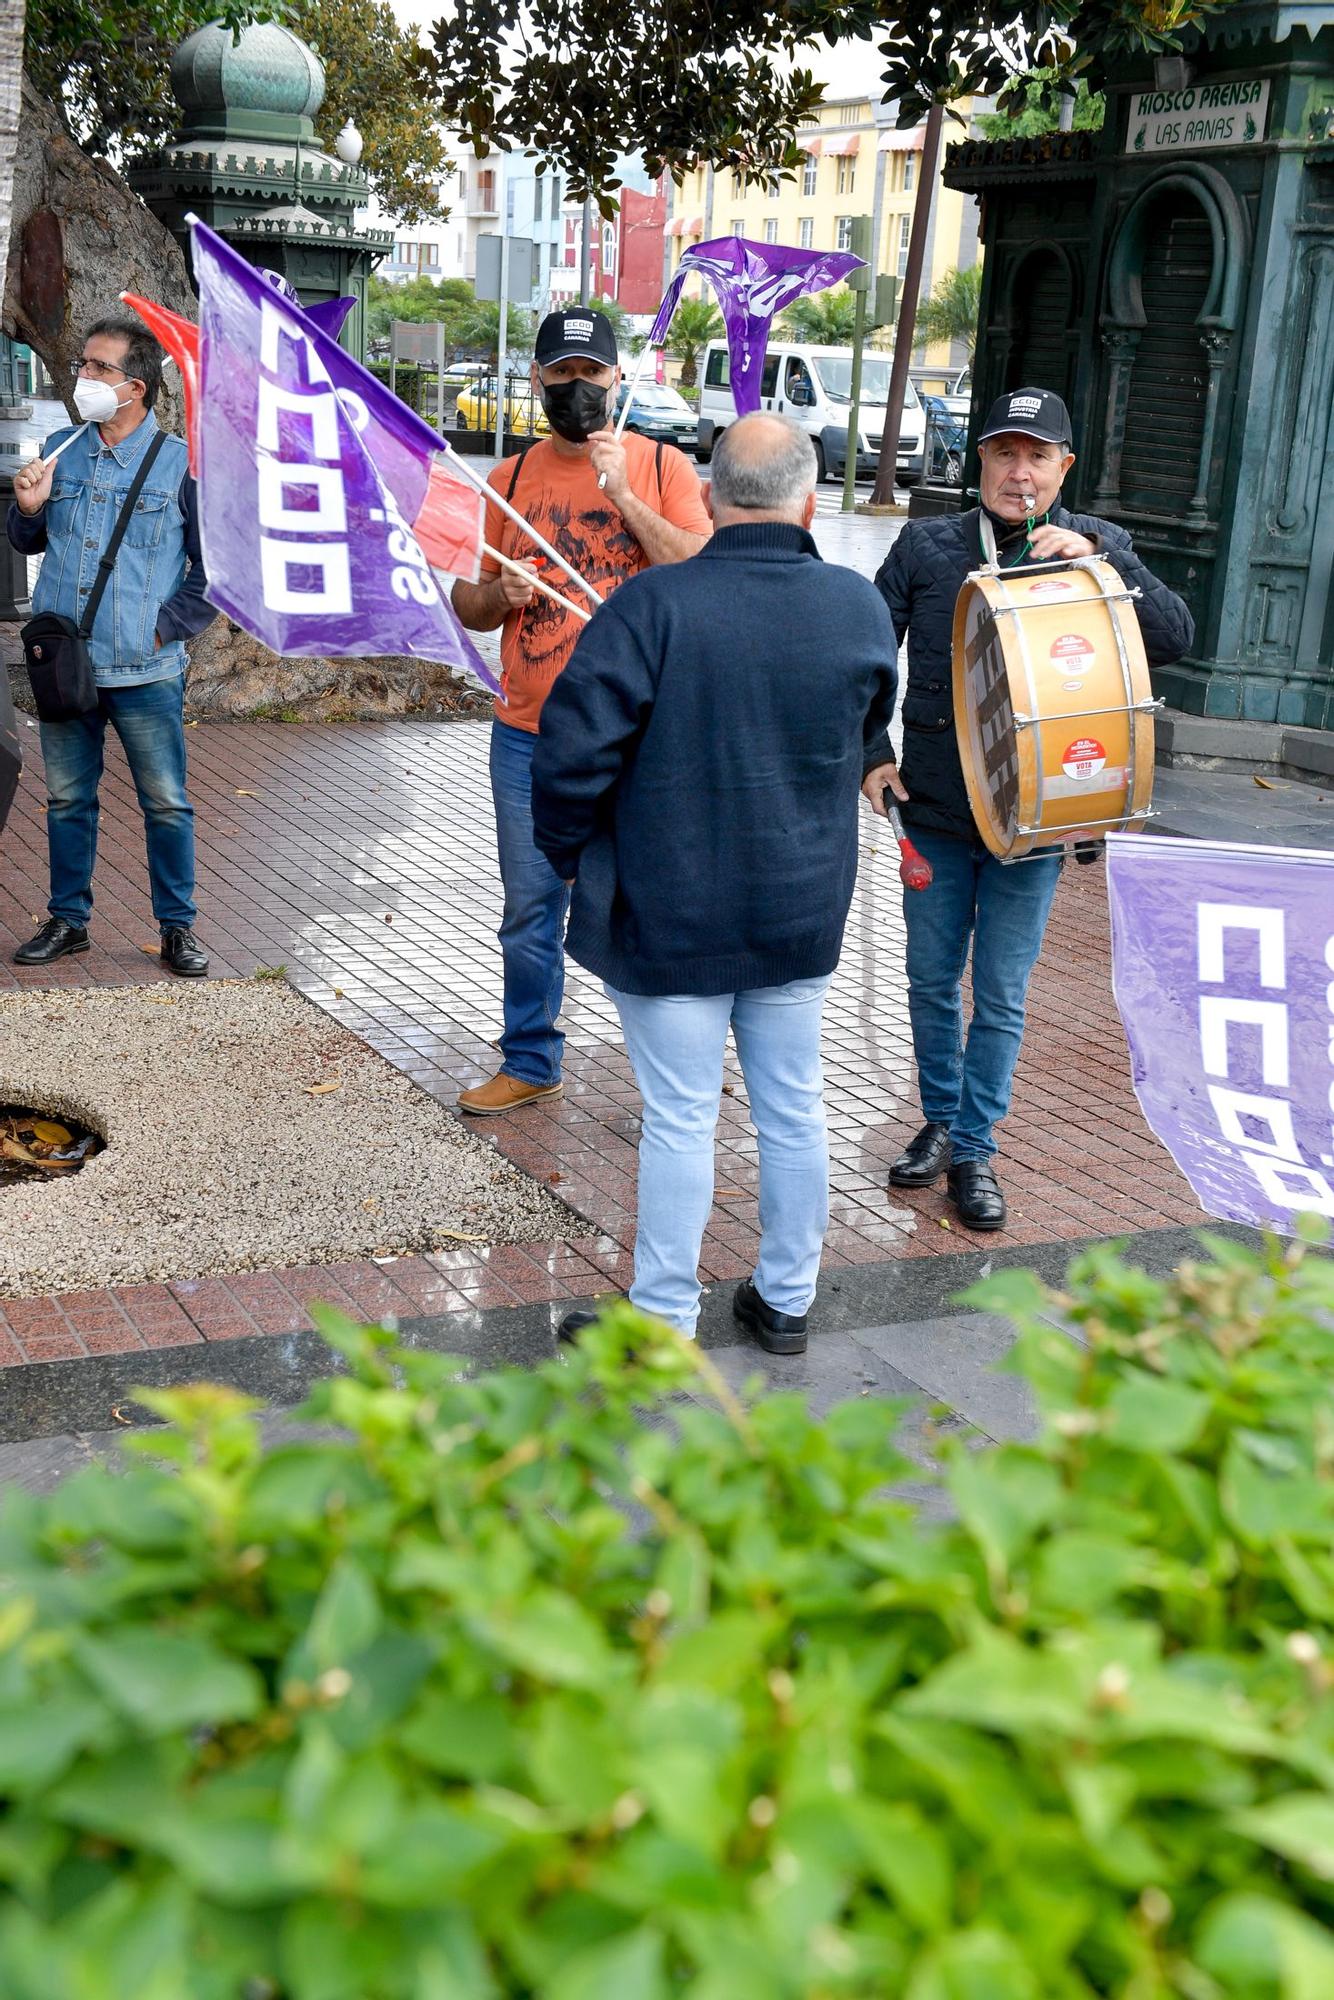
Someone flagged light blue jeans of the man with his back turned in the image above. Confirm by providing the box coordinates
[608,978,830,1334]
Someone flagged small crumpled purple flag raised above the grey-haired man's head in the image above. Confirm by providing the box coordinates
[648,236,862,416]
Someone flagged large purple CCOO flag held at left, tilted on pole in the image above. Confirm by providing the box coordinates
[192,222,496,688]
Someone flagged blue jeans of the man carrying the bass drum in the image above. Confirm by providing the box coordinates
[904,826,1060,1160]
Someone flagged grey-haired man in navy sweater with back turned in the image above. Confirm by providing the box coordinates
[532,416,898,1354]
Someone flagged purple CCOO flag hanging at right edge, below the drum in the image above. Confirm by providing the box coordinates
[1108,834,1334,1236]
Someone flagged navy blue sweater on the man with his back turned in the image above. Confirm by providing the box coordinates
[532,522,898,994]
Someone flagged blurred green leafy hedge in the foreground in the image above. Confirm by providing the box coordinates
[0,1240,1334,2000]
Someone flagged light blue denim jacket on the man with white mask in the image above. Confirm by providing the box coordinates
[6,410,216,688]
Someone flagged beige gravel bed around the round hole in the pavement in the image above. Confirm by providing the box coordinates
[0,980,588,1298]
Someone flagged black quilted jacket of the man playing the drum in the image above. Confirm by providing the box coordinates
[866,506,1194,836]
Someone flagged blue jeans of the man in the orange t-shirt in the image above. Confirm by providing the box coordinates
[490,722,570,1084]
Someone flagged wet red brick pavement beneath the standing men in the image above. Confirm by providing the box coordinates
[0,722,1200,1362]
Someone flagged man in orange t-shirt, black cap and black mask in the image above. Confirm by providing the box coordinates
[452,306,710,1118]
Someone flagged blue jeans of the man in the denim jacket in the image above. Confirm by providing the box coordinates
[42,674,196,930]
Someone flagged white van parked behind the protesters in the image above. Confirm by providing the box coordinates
[694,340,926,486]
